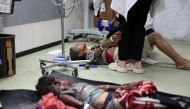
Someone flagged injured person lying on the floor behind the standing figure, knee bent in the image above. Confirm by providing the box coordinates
[70,29,190,73]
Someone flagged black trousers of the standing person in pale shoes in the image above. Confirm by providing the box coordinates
[118,0,152,60]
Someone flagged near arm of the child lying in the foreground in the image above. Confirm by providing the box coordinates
[59,93,93,109]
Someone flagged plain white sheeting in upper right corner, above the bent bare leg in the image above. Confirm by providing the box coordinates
[153,0,190,39]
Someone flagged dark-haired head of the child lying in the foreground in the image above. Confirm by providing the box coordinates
[36,76,71,95]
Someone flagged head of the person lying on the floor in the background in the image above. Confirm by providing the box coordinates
[69,43,88,60]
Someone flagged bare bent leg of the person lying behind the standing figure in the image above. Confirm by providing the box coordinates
[147,32,190,69]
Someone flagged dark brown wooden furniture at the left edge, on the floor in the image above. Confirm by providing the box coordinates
[0,34,16,78]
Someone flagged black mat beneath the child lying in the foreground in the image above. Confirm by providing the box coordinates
[0,71,190,109]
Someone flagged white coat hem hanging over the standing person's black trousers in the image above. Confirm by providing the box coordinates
[111,0,137,20]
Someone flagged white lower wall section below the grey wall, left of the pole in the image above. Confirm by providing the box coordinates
[4,19,61,53]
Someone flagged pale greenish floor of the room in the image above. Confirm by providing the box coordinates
[0,38,190,96]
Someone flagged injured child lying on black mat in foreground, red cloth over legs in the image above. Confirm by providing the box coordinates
[36,77,190,109]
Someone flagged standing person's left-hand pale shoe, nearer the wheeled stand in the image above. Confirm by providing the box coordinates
[108,61,127,73]
